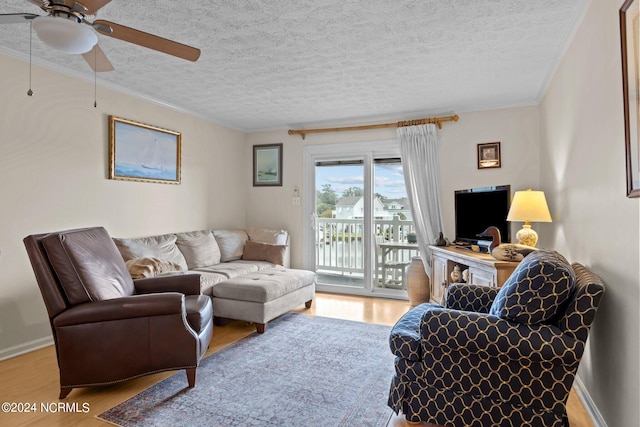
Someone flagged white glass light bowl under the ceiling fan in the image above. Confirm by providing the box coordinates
[33,16,98,54]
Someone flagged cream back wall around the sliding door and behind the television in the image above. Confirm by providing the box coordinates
[246,106,547,267]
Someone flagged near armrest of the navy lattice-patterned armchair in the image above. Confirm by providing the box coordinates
[420,308,584,365]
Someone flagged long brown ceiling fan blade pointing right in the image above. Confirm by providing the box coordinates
[93,19,200,61]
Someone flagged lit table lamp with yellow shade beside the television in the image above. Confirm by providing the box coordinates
[507,189,551,247]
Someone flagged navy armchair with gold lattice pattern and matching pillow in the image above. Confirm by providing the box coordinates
[388,251,604,427]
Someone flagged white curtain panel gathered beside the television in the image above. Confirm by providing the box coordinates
[397,124,444,275]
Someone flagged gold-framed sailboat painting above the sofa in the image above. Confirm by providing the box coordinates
[109,116,182,184]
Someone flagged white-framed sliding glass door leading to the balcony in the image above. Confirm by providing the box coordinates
[304,141,417,297]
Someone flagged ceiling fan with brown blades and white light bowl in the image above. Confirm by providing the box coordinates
[0,0,200,72]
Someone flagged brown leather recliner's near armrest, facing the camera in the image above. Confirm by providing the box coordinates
[53,292,185,327]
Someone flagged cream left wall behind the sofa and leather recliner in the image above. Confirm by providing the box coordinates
[0,55,248,357]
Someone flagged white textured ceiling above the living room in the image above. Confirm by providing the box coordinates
[0,0,589,131]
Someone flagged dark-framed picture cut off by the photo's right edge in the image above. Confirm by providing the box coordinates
[620,0,640,197]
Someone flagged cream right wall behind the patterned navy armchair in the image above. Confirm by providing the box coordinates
[540,0,640,427]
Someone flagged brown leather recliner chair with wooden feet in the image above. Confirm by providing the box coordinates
[24,227,213,399]
